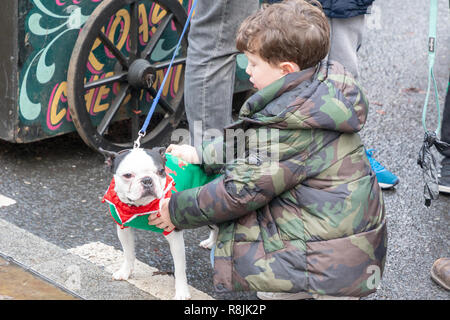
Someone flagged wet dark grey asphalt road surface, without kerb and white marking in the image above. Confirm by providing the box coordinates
[0,0,450,299]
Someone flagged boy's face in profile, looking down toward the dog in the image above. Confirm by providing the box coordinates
[244,51,287,90]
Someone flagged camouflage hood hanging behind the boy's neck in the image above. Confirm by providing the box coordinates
[239,60,369,133]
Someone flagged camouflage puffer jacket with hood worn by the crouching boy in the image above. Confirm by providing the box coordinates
[169,61,387,297]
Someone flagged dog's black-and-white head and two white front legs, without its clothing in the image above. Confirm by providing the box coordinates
[102,148,191,300]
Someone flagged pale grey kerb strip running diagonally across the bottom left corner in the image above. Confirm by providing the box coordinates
[0,219,153,300]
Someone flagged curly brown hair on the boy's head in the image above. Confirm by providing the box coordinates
[236,0,330,70]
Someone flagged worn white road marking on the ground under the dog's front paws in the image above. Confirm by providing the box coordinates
[67,242,213,300]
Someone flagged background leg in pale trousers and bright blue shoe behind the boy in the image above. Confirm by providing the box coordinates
[328,15,400,189]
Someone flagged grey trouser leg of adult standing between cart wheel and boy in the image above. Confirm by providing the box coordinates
[184,0,259,147]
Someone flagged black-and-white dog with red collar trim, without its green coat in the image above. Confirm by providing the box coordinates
[100,147,218,300]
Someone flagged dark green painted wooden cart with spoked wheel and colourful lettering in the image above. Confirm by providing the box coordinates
[0,0,250,150]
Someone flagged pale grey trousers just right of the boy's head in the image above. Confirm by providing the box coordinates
[328,15,364,78]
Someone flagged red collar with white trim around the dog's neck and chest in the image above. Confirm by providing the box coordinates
[102,174,176,235]
